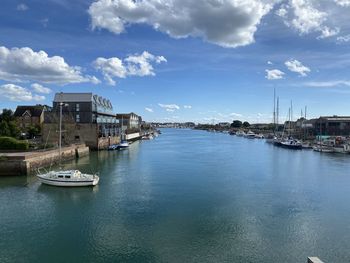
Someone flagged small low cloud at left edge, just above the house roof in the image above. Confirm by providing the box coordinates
[0,84,45,102]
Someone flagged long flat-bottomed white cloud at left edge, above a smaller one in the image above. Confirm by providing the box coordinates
[0,47,96,84]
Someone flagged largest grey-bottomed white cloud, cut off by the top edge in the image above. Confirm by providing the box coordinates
[88,0,273,47]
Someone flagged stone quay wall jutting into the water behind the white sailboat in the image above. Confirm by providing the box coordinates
[0,144,89,176]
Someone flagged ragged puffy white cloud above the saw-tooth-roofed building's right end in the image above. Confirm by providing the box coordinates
[93,51,167,86]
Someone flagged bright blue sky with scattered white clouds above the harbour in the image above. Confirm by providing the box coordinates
[0,0,350,123]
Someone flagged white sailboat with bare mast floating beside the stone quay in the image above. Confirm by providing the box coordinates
[37,102,100,187]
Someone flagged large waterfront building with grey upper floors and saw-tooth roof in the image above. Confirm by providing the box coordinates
[43,93,120,149]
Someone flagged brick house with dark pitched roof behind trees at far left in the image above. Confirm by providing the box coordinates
[14,105,48,132]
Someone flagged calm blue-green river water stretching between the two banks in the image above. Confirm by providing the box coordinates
[0,129,350,263]
